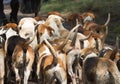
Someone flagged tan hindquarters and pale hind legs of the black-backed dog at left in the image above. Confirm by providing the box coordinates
[12,39,35,84]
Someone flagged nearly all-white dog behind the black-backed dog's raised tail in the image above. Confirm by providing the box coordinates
[18,17,37,50]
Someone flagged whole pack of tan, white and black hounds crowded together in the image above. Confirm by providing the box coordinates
[0,11,120,84]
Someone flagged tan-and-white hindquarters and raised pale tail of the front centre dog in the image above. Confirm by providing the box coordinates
[37,39,67,84]
